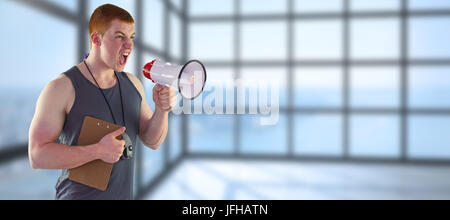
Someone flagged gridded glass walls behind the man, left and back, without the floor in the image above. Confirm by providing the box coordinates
[0,0,450,200]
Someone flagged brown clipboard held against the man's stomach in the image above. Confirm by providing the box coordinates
[69,116,123,191]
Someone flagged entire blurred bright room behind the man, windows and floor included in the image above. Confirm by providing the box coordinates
[0,0,450,200]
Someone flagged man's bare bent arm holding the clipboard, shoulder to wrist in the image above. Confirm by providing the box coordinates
[28,76,98,169]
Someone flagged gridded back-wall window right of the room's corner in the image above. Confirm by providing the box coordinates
[189,0,450,160]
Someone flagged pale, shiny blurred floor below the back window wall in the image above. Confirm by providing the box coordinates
[145,159,450,200]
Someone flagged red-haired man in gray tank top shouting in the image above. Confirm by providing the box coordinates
[28,4,177,199]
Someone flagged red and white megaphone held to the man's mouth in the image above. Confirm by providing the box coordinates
[142,59,206,99]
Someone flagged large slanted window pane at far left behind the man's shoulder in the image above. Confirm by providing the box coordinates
[0,1,76,149]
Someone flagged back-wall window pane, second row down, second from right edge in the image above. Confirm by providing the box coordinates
[350,19,400,59]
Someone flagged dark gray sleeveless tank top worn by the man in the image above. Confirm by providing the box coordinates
[55,66,142,199]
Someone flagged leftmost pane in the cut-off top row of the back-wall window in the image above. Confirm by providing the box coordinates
[189,0,234,16]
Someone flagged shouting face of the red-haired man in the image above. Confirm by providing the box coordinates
[100,19,135,72]
